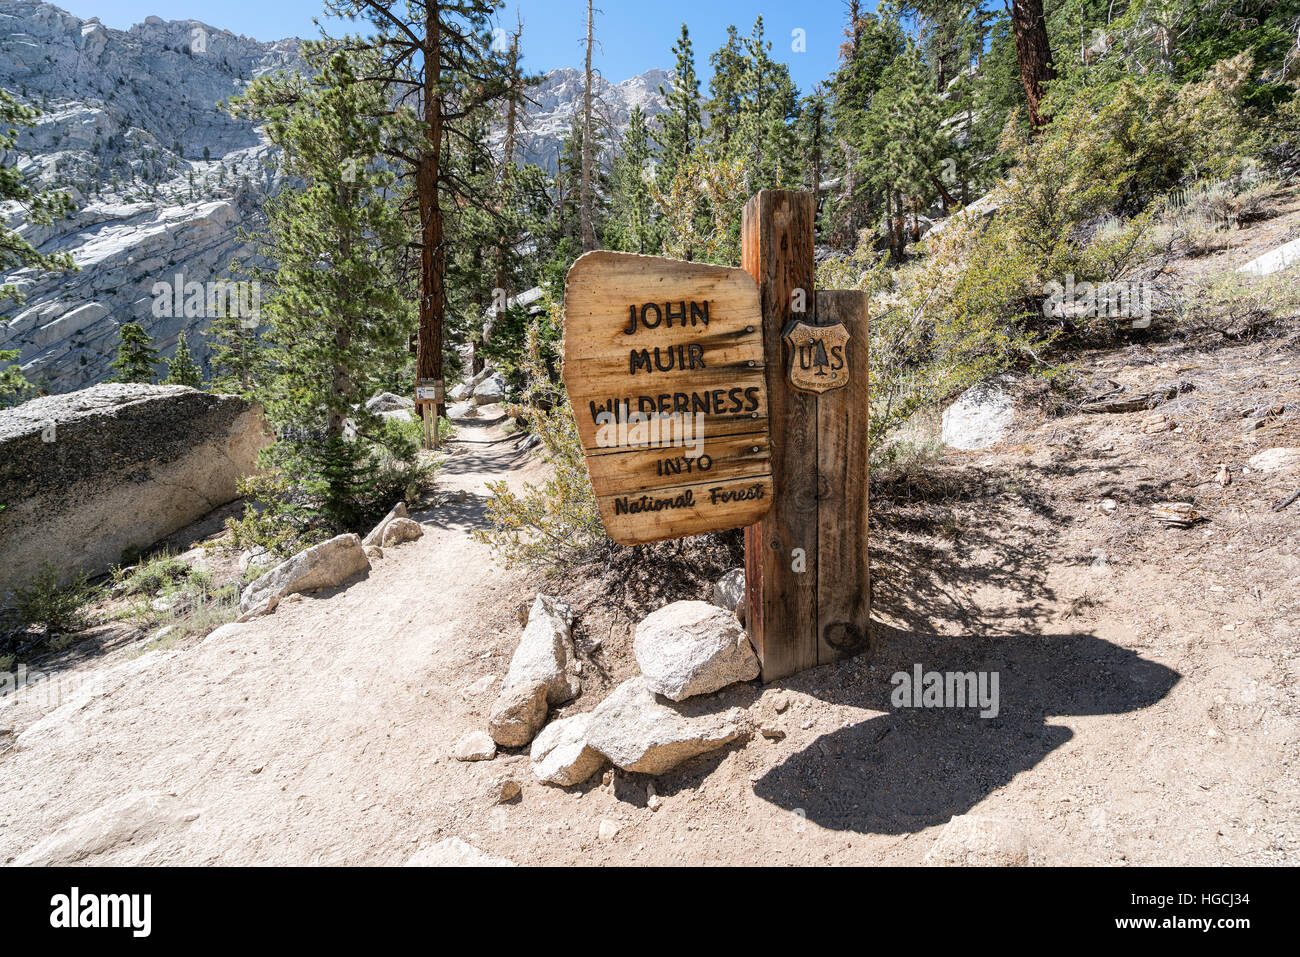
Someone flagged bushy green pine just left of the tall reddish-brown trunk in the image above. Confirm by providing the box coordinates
[233,43,412,531]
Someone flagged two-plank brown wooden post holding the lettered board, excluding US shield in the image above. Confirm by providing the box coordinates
[741,190,868,681]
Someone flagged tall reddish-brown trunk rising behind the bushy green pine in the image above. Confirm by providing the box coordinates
[415,0,447,429]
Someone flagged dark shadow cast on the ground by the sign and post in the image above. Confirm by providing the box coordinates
[754,623,1180,835]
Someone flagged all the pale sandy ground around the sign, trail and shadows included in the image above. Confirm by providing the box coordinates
[0,204,1300,865]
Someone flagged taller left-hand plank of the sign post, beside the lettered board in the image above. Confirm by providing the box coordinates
[741,190,818,681]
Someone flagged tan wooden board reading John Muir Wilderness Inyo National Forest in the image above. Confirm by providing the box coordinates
[564,251,772,545]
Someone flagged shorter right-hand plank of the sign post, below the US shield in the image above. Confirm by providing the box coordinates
[816,290,871,664]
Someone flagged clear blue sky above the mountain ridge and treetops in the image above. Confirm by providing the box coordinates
[53,0,875,92]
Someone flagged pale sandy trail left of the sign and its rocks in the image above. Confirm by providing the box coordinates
[0,408,534,863]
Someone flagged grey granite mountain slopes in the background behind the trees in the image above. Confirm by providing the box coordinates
[0,0,668,393]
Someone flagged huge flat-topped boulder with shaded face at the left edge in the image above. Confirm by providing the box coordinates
[0,384,270,594]
